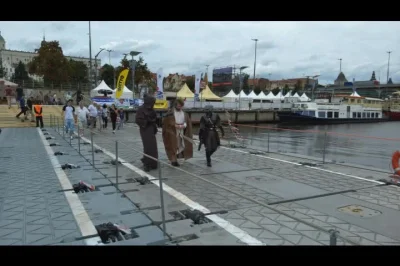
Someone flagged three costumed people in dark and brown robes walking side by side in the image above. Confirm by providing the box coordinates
[135,95,224,172]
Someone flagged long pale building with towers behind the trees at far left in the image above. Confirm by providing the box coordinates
[0,31,101,80]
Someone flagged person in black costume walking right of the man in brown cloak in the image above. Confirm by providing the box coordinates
[199,105,225,167]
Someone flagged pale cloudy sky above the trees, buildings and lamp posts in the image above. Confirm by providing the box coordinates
[0,21,400,84]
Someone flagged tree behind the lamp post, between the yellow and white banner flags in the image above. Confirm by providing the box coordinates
[115,57,153,92]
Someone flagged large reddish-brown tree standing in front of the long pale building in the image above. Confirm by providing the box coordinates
[28,41,69,83]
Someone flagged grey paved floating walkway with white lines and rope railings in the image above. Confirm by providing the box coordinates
[0,125,400,245]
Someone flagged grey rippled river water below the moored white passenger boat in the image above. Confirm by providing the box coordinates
[195,122,400,171]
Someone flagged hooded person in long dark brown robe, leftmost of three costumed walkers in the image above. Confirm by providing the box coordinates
[135,95,158,172]
